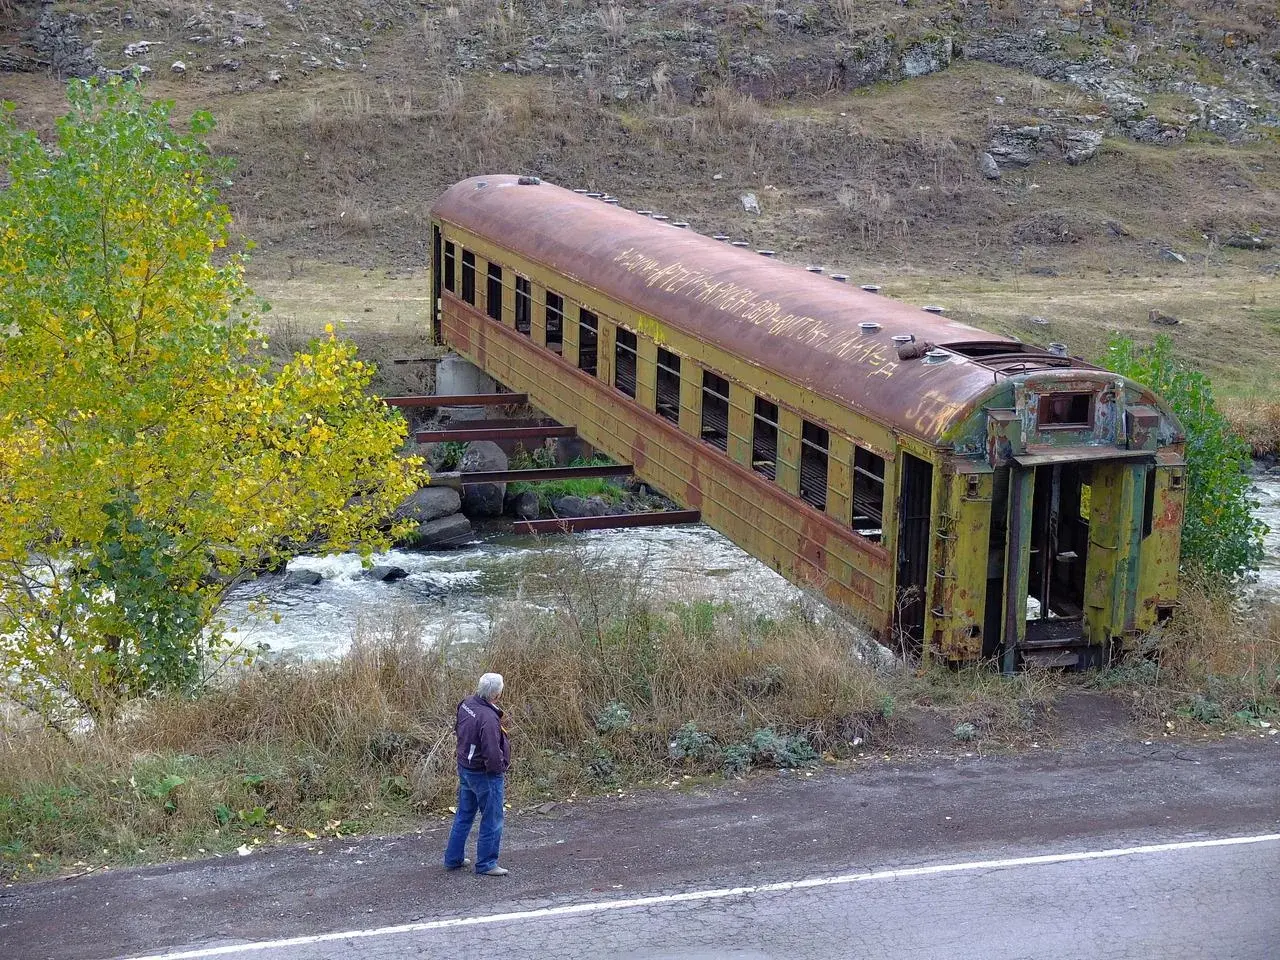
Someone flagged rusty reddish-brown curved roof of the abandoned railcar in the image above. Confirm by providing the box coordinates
[433,175,1093,442]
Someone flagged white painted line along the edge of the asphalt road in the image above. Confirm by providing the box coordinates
[117,833,1280,960]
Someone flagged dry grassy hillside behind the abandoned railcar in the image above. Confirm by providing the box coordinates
[0,1,1280,414]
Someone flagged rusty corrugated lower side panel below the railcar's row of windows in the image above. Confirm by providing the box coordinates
[443,300,891,631]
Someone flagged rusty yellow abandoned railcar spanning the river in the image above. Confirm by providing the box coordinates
[431,175,1185,669]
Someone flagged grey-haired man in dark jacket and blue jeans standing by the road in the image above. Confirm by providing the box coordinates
[444,673,511,877]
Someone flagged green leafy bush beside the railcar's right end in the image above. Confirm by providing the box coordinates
[1102,337,1267,581]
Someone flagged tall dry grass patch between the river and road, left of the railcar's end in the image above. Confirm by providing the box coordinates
[0,557,884,874]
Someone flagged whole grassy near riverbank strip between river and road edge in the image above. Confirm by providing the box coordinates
[0,554,1280,879]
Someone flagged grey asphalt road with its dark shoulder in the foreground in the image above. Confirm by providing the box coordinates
[0,737,1280,960]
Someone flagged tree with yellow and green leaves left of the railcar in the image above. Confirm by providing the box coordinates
[0,82,421,724]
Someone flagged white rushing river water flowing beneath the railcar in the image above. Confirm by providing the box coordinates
[224,477,1280,658]
